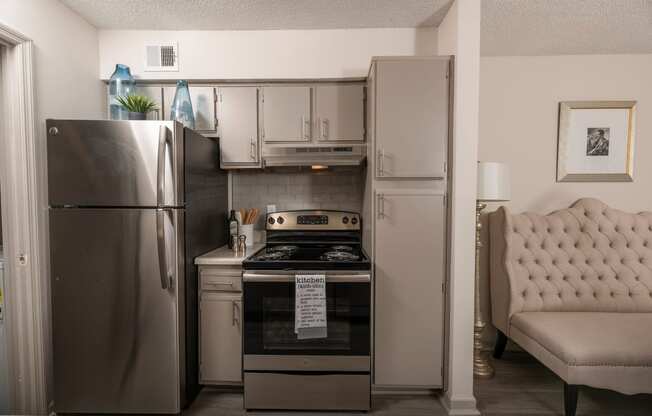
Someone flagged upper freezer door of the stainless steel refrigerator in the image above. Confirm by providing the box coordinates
[47,120,184,207]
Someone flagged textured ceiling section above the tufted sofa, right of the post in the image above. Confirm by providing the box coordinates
[482,0,652,55]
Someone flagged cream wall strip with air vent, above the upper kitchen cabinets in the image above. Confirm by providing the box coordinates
[99,29,437,80]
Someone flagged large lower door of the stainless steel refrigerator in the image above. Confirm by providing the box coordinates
[50,208,185,413]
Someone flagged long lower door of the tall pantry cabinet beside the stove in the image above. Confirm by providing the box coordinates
[374,190,446,387]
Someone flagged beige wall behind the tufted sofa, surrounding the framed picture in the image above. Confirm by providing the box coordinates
[479,55,652,340]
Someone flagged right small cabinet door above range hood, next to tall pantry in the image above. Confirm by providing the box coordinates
[313,85,364,141]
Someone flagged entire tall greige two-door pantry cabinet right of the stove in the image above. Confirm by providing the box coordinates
[363,57,451,389]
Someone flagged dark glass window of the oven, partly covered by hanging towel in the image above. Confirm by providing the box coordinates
[263,297,351,352]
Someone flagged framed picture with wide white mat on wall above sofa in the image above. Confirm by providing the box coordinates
[557,101,636,182]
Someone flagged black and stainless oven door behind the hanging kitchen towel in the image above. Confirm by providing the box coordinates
[243,271,371,371]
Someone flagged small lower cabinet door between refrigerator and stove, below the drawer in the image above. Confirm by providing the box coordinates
[199,292,242,384]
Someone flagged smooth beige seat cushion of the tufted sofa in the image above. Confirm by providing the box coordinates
[510,312,652,394]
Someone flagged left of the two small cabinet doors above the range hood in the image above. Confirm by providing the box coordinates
[262,86,312,142]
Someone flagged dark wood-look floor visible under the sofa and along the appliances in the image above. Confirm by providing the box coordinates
[184,351,652,416]
